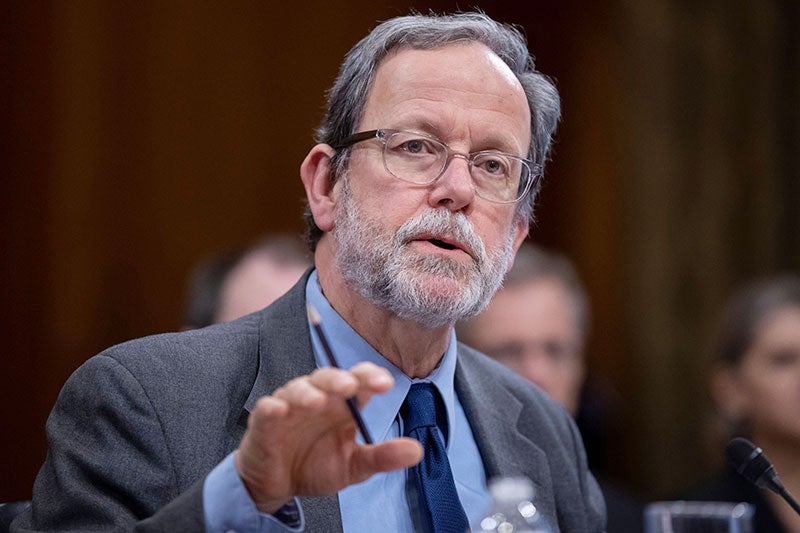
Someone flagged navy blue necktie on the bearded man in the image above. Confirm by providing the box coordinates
[400,383,469,533]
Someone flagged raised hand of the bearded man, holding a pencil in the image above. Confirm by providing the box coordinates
[234,363,423,513]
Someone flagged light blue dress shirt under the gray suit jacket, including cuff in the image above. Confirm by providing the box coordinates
[203,271,490,533]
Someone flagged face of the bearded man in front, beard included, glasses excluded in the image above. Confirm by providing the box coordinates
[333,43,530,327]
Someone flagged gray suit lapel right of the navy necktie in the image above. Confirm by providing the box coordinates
[455,346,555,516]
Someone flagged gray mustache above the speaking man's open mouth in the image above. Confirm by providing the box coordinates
[395,208,487,265]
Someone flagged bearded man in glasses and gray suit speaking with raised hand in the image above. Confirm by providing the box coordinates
[15,13,604,532]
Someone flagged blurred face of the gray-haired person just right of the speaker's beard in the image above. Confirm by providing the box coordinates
[469,278,585,415]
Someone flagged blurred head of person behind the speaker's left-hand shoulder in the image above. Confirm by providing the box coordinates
[183,234,311,329]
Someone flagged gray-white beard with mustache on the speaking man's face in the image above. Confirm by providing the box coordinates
[333,177,514,328]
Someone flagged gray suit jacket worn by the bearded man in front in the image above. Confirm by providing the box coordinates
[12,275,605,533]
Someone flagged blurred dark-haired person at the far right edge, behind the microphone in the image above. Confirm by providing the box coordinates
[680,274,800,533]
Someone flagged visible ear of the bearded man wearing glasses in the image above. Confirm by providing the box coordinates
[300,144,336,232]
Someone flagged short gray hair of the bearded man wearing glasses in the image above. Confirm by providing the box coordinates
[305,12,561,250]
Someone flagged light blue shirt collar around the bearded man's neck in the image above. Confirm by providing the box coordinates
[306,270,457,442]
